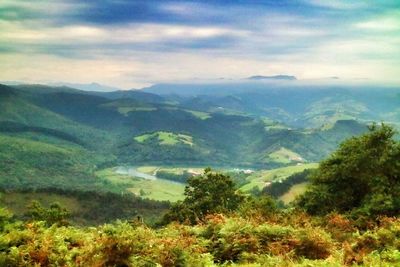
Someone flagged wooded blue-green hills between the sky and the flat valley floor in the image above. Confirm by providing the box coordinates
[0,83,384,193]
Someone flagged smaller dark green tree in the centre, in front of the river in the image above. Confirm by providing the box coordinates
[163,168,244,223]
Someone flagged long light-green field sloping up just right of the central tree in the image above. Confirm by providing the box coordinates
[240,163,318,192]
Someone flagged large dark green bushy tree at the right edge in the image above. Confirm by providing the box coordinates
[298,124,400,216]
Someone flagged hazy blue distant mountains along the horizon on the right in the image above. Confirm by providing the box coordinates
[142,80,400,128]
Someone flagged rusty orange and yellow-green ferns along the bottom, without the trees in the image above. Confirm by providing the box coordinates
[0,205,400,267]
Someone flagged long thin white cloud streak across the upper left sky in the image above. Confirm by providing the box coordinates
[0,21,248,44]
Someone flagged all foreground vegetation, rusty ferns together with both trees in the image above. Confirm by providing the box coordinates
[0,125,400,266]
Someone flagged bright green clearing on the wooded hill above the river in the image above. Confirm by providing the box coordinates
[135,131,193,146]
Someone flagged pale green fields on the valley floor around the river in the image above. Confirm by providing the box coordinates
[96,163,318,203]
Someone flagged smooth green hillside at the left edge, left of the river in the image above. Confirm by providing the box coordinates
[0,135,105,190]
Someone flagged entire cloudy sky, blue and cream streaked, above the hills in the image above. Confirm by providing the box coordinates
[0,0,400,89]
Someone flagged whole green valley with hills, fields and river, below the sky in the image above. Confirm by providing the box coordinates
[0,80,400,211]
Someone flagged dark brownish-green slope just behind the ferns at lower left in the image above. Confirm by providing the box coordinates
[0,188,170,225]
